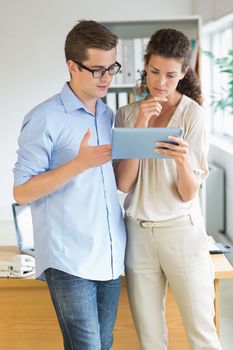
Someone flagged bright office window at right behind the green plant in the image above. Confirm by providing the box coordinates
[202,13,233,142]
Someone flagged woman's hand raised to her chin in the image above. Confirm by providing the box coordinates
[134,96,167,128]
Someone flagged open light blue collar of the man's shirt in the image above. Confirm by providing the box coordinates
[60,83,107,114]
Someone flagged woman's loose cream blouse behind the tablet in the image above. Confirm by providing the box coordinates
[115,95,208,221]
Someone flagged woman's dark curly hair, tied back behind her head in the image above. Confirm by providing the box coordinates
[140,28,203,105]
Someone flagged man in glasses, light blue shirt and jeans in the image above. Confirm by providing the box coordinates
[14,20,125,350]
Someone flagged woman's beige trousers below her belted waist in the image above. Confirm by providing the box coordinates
[126,215,222,350]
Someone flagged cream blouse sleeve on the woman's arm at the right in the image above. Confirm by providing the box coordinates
[184,106,209,183]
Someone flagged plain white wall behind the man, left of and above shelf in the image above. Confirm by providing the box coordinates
[0,0,192,220]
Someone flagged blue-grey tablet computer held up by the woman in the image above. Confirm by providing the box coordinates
[112,127,183,159]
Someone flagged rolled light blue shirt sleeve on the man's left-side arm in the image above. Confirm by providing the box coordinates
[13,113,53,186]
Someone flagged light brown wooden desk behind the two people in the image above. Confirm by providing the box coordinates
[0,247,233,350]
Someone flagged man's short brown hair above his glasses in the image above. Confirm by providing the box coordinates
[65,20,118,62]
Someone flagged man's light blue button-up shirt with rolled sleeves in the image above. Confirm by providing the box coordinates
[14,84,126,280]
